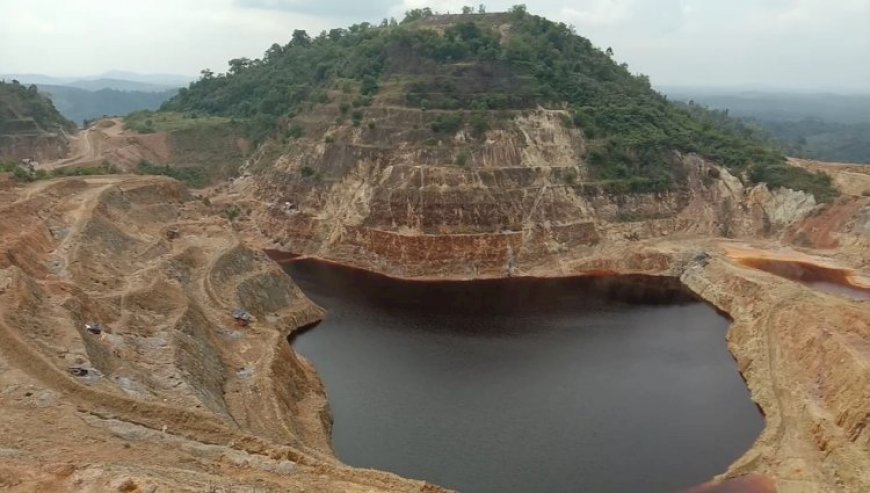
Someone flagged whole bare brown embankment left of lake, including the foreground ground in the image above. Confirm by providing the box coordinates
[0,177,442,491]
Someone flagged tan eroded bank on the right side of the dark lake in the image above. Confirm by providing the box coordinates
[680,258,870,493]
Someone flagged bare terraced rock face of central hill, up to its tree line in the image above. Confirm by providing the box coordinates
[244,106,816,276]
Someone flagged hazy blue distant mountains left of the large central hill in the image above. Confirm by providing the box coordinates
[0,71,193,125]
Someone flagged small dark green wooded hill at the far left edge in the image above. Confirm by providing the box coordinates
[0,81,76,135]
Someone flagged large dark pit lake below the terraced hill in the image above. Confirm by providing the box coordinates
[287,261,763,493]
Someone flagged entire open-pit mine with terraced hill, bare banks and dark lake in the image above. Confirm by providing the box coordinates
[0,7,870,493]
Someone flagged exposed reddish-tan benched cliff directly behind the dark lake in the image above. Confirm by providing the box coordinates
[252,143,832,277]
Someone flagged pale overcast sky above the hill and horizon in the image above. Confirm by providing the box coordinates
[0,0,870,93]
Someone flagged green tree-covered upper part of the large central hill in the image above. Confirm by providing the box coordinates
[163,6,835,200]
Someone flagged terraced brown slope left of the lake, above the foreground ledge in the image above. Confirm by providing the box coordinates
[0,177,337,464]
